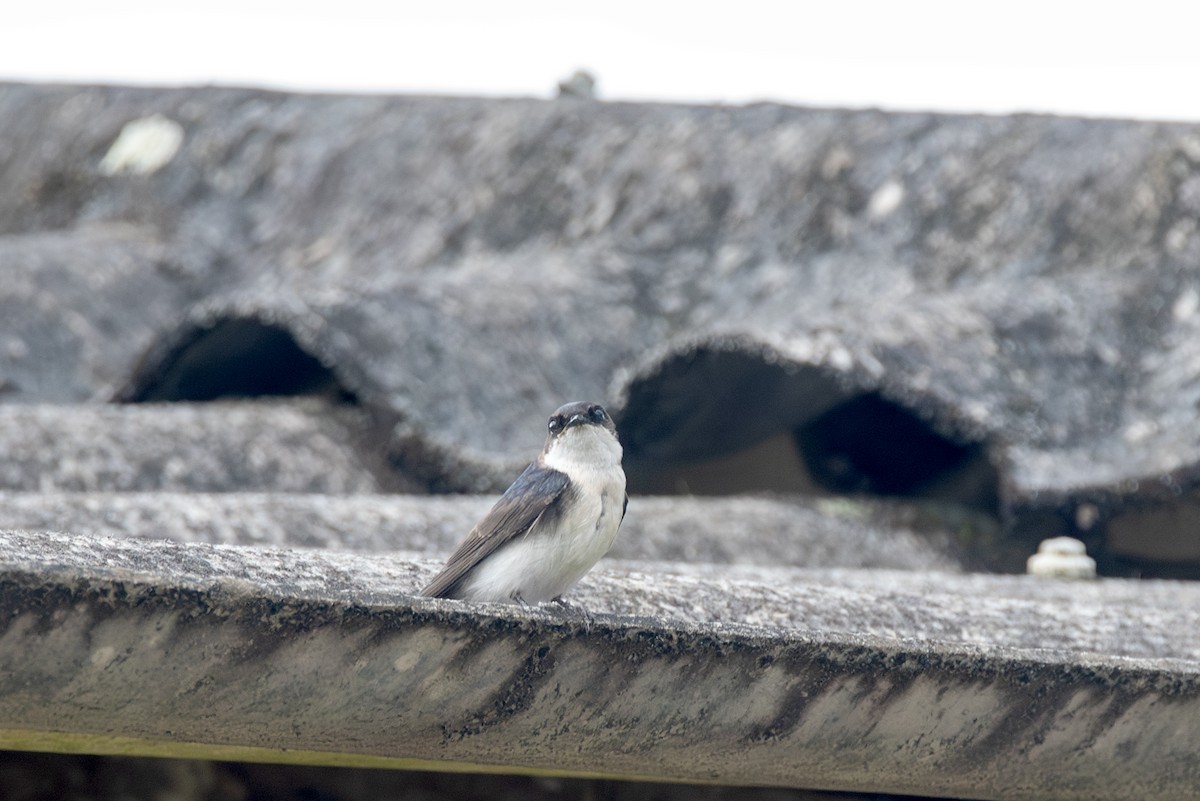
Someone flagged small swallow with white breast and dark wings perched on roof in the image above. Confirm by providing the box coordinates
[421,401,629,607]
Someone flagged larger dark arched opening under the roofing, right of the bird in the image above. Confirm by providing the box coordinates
[619,347,1000,512]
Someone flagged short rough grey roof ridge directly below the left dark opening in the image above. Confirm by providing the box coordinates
[0,402,388,493]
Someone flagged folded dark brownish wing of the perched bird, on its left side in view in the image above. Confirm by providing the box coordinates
[421,463,568,598]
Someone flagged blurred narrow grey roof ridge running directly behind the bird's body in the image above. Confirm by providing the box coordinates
[0,492,979,572]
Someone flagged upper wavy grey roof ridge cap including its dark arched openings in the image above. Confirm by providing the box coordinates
[0,79,1200,566]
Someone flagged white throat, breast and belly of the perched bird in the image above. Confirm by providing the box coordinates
[463,426,625,603]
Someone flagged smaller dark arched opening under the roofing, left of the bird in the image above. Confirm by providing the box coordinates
[120,319,347,403]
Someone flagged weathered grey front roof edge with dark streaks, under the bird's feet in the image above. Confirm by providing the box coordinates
[0,531,1200,800]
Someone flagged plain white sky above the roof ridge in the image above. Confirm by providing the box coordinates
[7,0,1200,121]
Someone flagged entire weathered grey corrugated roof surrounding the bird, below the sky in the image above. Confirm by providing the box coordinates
[0,77,1200,799]
